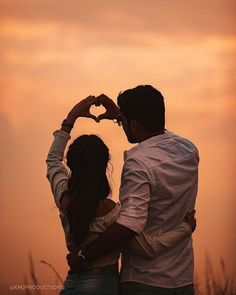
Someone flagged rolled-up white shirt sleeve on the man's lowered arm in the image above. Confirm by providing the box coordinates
[116,157,150,233]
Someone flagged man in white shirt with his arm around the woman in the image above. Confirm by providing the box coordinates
[68,85,199,295]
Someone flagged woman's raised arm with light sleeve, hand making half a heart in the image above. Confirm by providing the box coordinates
[46,96,97,209]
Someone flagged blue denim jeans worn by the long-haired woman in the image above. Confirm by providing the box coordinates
[60,265,119,295]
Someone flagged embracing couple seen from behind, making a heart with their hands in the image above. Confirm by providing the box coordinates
[46,85,199,295]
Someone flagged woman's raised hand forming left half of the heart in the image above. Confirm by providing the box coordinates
[66,95,98,124]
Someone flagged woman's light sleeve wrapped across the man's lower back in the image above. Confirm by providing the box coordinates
[127,222,192,258]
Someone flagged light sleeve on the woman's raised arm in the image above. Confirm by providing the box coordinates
[46,130,71,208]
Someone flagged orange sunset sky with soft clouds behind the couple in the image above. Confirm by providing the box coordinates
[0,0,236,294]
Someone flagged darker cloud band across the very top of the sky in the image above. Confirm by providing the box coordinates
[0,0,236,37]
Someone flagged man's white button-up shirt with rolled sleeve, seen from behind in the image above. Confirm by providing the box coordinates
[117,131,199,288]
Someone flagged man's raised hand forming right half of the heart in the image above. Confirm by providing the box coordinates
[96,94,120,121]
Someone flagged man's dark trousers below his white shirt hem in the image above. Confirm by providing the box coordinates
[120,282,194,295]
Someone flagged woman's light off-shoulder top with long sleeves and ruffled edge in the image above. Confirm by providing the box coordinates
[46,130,191,267]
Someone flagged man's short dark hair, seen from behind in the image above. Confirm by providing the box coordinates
[117,85,165,132]
